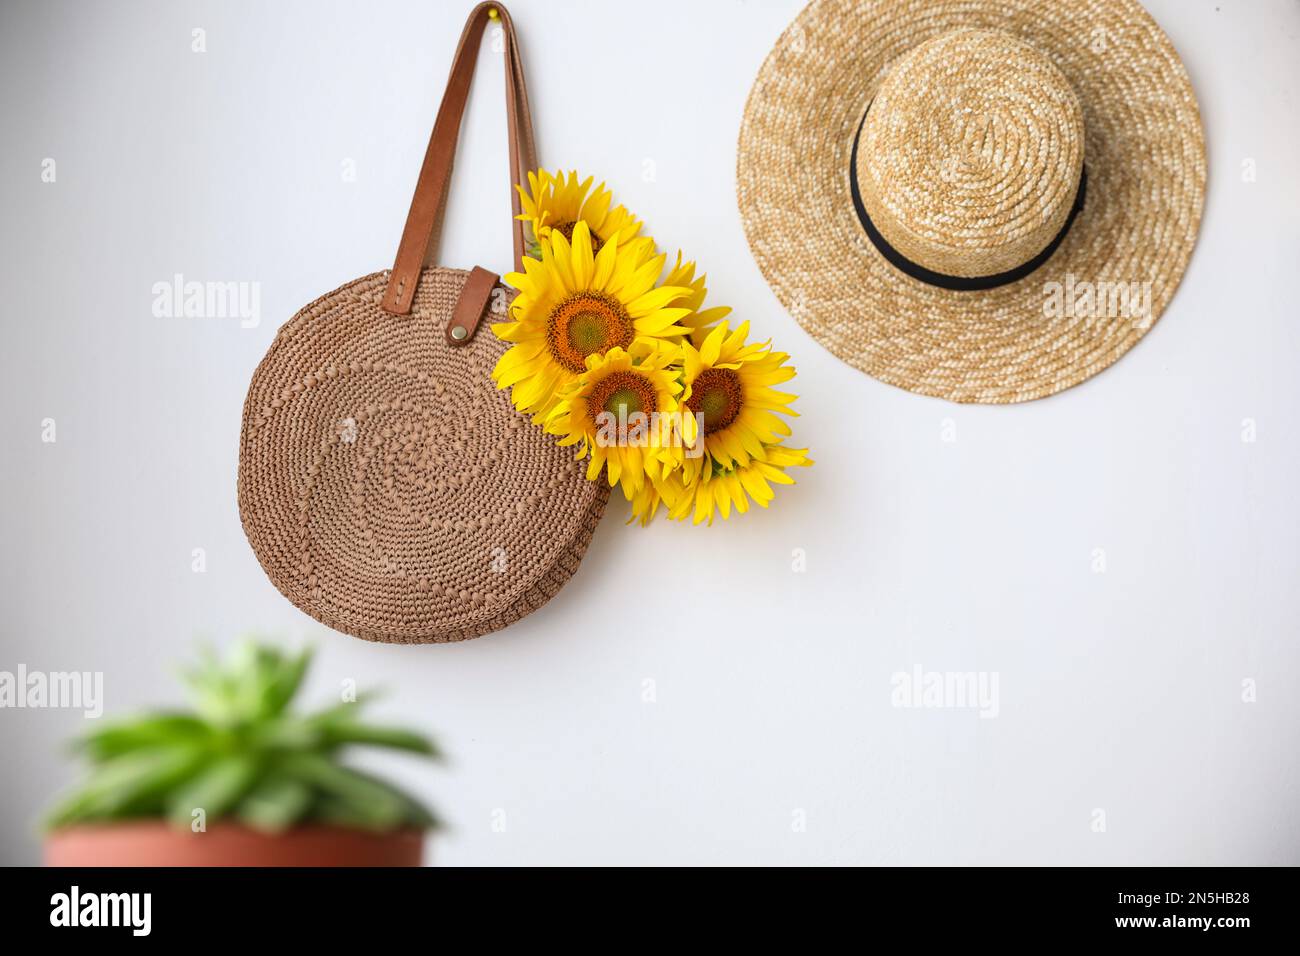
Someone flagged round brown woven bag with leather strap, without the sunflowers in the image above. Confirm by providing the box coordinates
[239,4,608,644]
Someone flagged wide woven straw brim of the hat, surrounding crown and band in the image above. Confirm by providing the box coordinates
[736,0,1206,405]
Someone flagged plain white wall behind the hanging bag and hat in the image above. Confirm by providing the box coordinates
[0,0,1300,864]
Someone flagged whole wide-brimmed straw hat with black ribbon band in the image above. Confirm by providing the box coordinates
[737,0,1205,403]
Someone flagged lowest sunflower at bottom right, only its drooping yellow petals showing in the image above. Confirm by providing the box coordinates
[665,444,813,524]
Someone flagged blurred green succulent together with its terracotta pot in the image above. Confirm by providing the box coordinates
[46,643,439,866]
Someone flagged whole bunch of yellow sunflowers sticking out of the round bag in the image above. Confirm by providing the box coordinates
[493,169,813,524]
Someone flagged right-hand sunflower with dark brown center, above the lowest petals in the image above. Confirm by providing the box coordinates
[683,321,797,476]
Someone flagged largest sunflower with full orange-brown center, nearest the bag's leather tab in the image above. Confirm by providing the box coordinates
[491,221,690,423]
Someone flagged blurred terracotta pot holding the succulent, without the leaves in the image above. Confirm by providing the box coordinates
[46,821,424,866]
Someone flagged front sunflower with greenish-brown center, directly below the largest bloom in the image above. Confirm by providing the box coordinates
[545,338,681,509]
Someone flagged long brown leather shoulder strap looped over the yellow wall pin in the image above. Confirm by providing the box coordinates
[382,3,537,317]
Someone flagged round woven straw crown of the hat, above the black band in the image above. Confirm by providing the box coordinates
[855,30,1084,277]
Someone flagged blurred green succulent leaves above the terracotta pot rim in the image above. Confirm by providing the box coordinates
[48,641,441,832]
